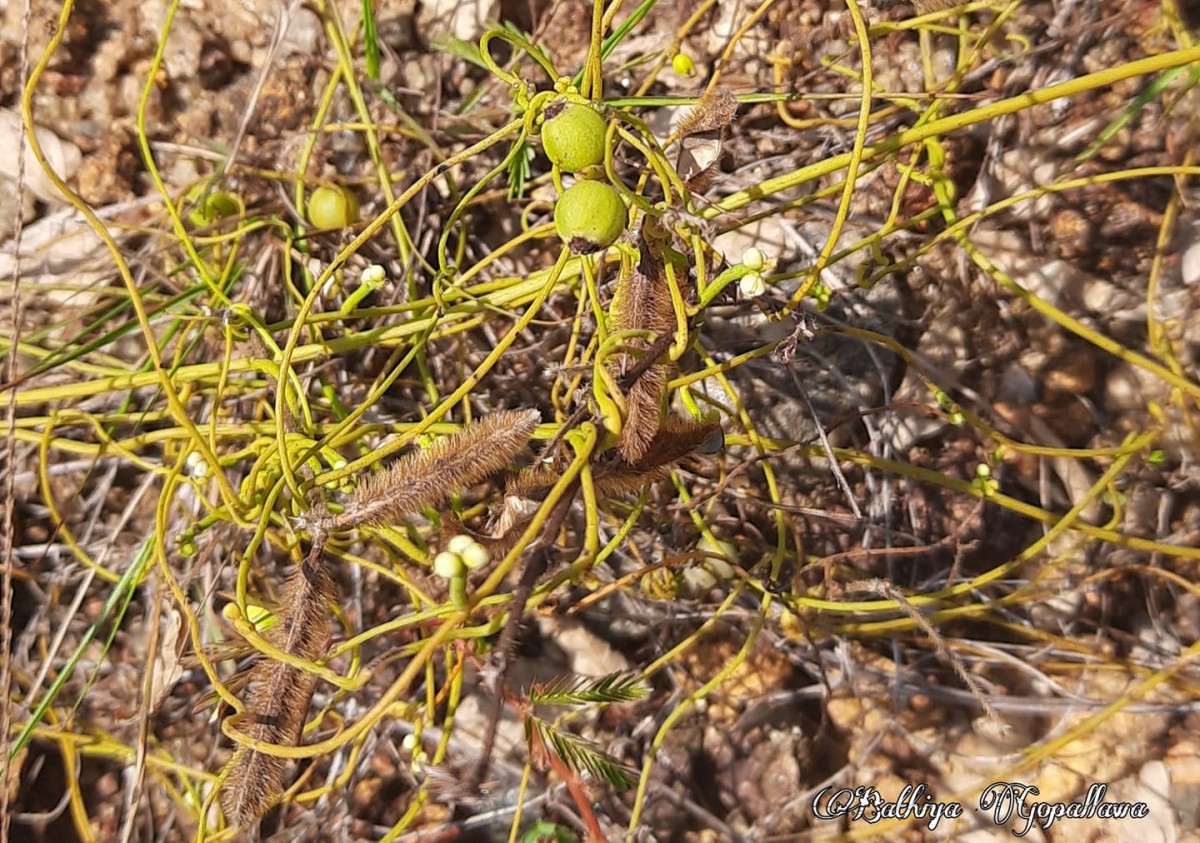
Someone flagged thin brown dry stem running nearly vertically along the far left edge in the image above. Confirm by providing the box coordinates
[0,0,34,841]
